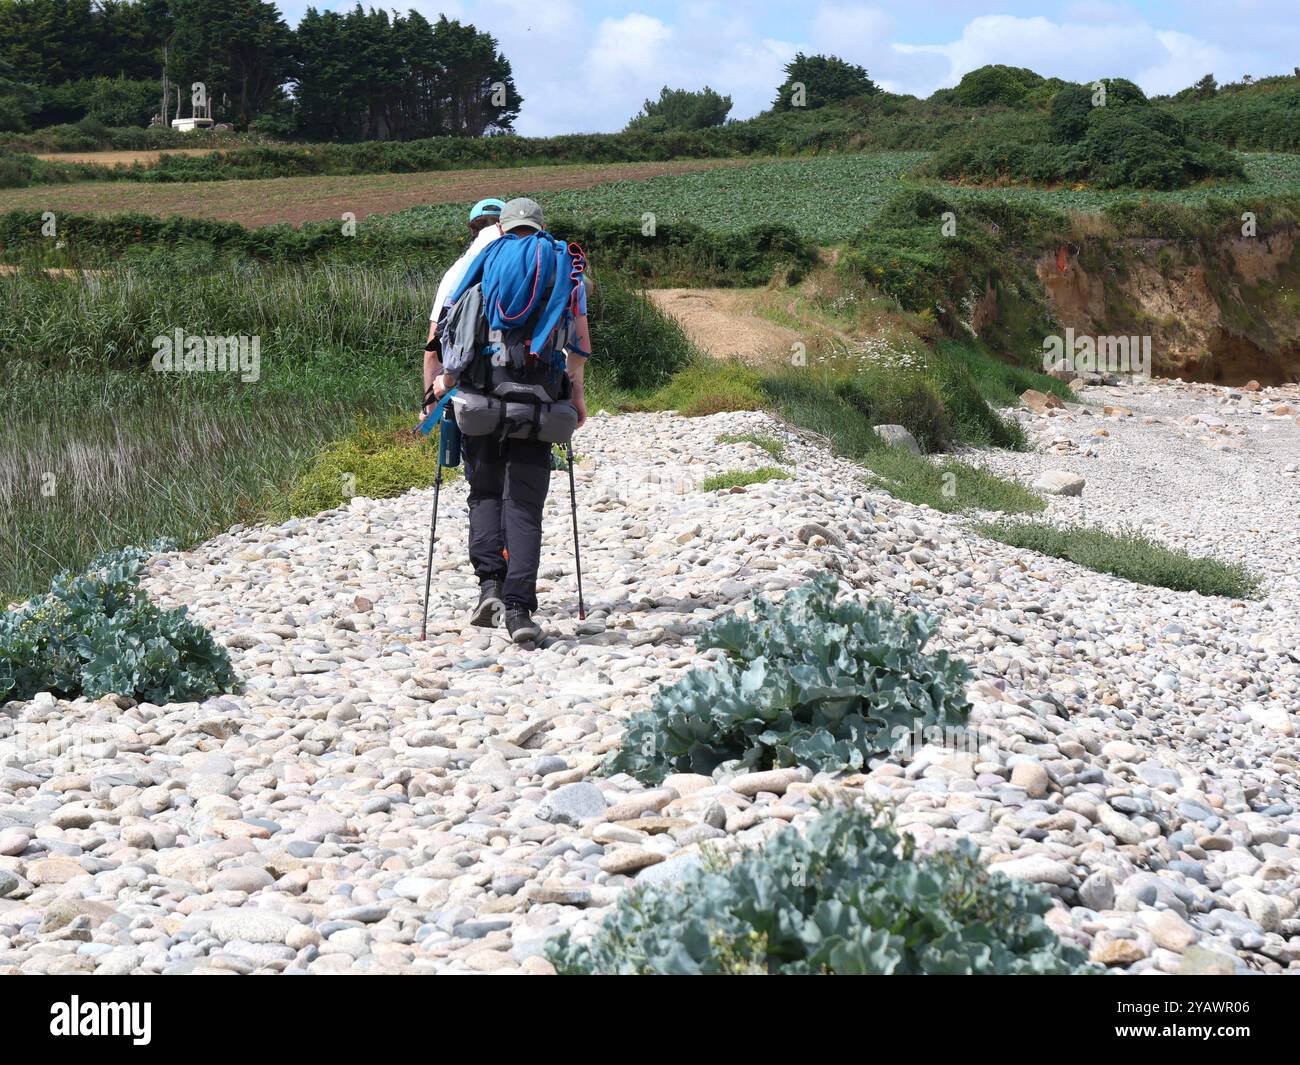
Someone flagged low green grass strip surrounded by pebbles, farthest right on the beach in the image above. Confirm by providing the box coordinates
[976,521,1260,599]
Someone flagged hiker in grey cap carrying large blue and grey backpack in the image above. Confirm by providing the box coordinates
[433,198,592,644]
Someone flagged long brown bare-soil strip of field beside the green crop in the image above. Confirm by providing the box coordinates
[0,159,753,226]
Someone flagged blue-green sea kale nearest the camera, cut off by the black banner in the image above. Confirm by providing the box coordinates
[546,806,1095,975]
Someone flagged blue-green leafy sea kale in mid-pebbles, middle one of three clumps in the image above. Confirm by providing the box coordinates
[606,573,970,784]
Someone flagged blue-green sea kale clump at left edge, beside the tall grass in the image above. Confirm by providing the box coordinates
[0,547,235,703]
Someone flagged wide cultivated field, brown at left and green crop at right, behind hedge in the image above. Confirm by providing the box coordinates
[10,152,1300,244]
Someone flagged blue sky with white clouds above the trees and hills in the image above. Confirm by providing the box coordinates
[280,0,1300,135]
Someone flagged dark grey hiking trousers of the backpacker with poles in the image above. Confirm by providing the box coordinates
[460,437,551,611]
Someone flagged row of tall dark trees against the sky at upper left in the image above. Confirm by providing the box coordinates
[0,0,523,140]
